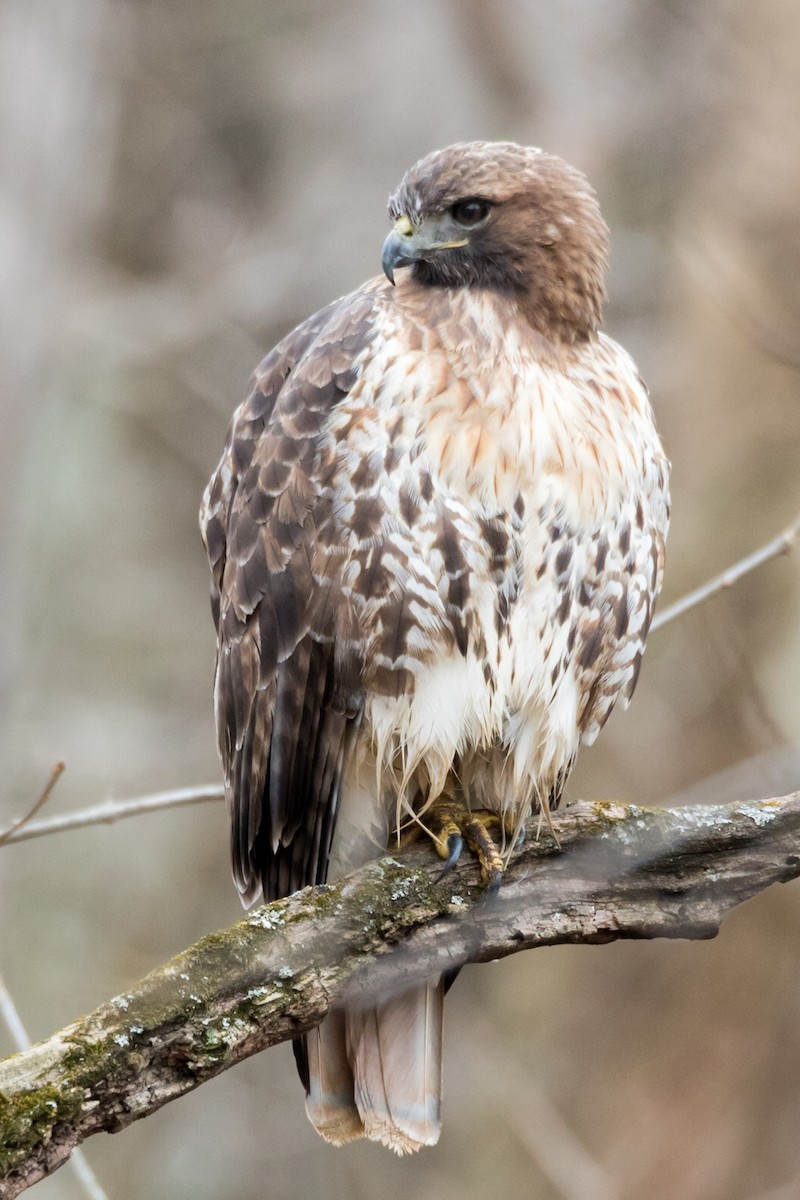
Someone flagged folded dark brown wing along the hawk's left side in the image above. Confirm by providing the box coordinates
[203,294,372,902]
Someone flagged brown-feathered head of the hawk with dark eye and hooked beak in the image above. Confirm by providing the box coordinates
[383,142,608,341]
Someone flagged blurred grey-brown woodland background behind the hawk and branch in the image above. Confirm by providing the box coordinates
[0,0,800,1200]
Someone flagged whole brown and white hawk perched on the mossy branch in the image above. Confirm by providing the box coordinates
[201,142,668,1153]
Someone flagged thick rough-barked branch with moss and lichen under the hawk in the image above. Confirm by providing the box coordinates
[0,793,800,1200]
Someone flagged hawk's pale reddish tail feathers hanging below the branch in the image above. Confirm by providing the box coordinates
[306,979,444,1154]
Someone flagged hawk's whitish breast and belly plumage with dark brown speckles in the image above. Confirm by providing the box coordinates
[323,288,667,854]
